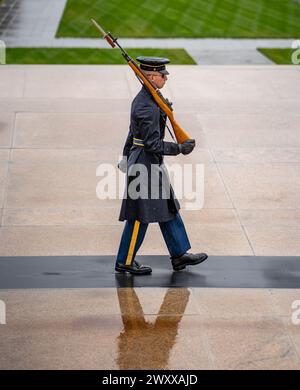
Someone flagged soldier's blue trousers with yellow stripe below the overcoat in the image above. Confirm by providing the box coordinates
[117,213,191,265]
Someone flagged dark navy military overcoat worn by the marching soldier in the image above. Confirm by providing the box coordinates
[119,86,180,223]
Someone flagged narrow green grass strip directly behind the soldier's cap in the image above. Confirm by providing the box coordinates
[6,48,195,65]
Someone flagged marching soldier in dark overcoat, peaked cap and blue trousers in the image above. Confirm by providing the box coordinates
[115,57,207,275]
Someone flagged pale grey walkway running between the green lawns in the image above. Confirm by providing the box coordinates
[0,0,293,65]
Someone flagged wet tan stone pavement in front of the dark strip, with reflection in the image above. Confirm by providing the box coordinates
[0,286,300,368]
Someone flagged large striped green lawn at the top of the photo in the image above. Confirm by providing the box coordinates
[57,0,300,38]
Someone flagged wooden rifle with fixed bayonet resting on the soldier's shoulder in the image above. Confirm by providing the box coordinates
[91,19,191,144]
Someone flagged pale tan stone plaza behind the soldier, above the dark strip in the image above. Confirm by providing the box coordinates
[0,65,300,256]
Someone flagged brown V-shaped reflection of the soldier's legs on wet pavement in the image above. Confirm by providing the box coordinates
[117,280,190,370]
